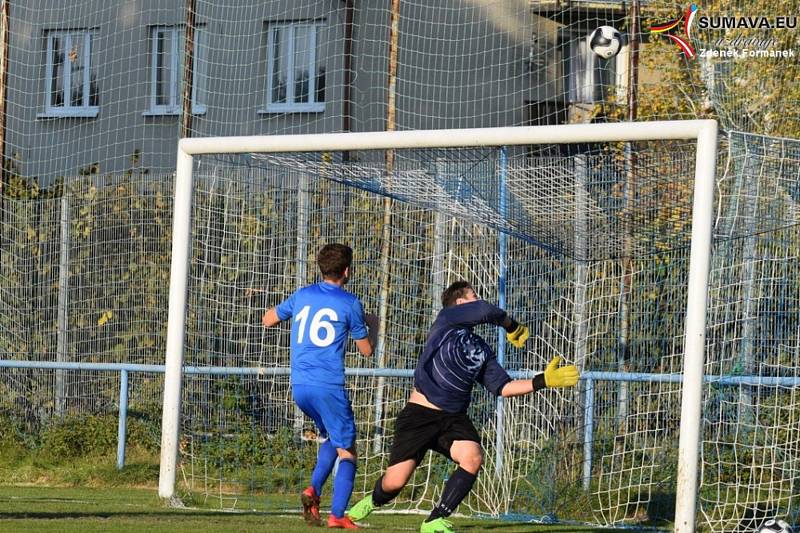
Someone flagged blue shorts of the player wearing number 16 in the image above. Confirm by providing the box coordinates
[292,385,356,449]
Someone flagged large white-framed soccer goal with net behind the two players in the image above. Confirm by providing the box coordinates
[159,120,717,532]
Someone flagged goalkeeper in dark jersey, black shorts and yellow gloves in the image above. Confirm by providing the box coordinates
[347,281,580,533]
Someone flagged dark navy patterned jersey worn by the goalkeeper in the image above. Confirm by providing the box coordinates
[414,300,511,413]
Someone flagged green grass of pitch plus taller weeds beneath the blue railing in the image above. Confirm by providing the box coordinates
[0,419,664,533]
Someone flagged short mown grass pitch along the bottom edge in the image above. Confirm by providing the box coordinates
[0,485,652,533]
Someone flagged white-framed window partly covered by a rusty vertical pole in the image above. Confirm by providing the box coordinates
[145,26,208,115]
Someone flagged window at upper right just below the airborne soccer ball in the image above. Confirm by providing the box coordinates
[562,34,624,104]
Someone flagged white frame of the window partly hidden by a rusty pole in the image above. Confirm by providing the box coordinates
[142,24,208,117]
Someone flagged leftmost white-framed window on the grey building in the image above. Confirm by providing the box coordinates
[40,31,100,117]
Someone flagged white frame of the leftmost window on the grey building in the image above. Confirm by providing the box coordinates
[37,29,100,118]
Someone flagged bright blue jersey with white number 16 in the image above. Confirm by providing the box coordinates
[275,281,367,387]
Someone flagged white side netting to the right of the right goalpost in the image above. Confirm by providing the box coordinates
[699,133,800,531]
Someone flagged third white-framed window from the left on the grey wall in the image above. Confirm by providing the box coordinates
[266,22,325,113]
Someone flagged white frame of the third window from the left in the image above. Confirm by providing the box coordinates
[259,20,325,113]
